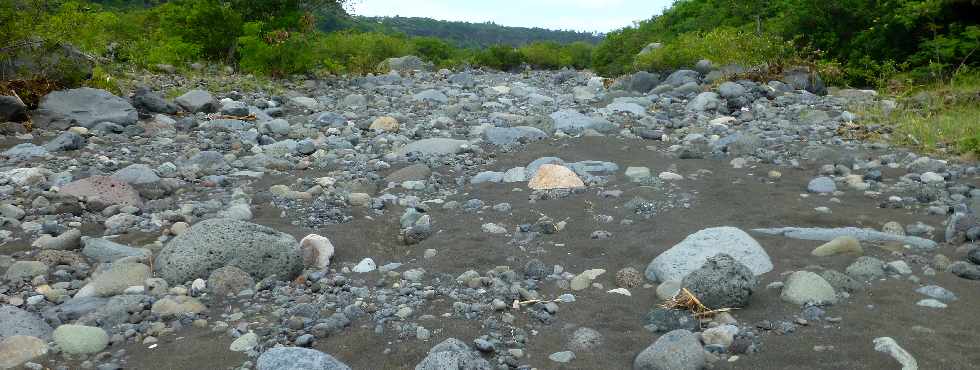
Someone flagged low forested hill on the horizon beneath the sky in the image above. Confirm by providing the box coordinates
[354,16,603,48]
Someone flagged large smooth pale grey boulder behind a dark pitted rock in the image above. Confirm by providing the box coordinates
[646,226,772,282]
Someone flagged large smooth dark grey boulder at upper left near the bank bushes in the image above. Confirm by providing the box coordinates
[34,87,139,130]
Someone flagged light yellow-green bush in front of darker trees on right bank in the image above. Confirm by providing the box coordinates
[636,27,794,71]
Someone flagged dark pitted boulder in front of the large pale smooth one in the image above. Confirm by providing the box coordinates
[681,254,758,308]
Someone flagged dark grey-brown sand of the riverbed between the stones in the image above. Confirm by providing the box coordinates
[32,138,980,370]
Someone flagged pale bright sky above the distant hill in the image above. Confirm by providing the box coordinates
[348,0,673,32]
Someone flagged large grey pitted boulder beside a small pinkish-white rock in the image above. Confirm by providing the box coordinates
[155,218,303,284]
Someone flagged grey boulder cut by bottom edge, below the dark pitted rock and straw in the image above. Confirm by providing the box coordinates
[633,329,705,370]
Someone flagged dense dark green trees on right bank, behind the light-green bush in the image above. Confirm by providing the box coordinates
[593,0,980,86]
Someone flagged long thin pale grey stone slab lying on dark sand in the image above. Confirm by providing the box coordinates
[752,227,936,250]
